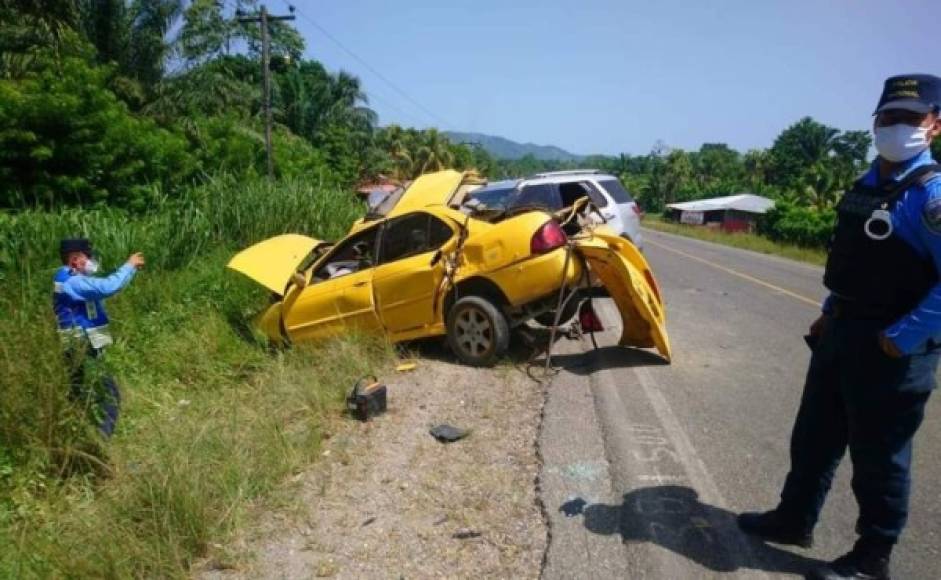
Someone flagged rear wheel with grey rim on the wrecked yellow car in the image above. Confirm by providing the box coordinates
[447,296,510,367]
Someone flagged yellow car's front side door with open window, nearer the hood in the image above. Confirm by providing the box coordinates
[283,224,382,341]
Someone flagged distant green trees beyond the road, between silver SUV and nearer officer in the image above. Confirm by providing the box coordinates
[492,118,871,248]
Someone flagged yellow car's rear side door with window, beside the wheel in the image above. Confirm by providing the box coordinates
[373,212,457,339]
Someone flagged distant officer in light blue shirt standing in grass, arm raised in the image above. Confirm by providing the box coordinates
[52,238,144,437]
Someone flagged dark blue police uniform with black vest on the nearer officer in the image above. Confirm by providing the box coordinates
[779,151,941,542]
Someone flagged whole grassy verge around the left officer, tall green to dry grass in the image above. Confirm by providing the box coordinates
[0,180,392,578]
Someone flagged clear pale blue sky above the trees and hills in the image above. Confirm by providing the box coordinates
[290,0,941,154]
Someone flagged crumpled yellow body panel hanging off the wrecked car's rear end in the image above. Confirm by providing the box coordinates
[576,234,672,360]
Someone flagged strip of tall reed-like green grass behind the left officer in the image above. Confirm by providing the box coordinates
[0,176,363,282]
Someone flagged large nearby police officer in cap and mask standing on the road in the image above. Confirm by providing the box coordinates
[739,74,941,580]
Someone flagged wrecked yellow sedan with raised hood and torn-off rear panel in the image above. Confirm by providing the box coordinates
[228,171,670,366]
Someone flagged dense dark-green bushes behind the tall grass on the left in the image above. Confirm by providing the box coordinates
[0,58,341,213]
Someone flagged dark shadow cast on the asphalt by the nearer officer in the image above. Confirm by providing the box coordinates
[559,485,820,575]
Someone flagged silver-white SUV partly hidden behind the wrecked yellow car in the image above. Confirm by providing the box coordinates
[465,169,644,250]
